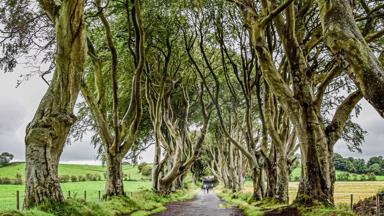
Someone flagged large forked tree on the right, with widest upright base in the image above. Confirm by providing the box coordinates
[233,0,362,205]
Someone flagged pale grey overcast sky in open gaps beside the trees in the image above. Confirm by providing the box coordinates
[0,66,384,164]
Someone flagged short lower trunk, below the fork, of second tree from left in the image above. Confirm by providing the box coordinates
[104,154,125,197]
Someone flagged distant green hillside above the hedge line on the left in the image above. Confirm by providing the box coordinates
[0,162,146,180]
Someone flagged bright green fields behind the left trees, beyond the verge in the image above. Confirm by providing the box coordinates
[0,163,151,211]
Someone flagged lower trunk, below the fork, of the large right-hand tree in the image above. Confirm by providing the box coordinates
[295,108,333,206]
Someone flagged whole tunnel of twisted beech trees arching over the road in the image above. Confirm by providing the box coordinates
[0,0,384,211]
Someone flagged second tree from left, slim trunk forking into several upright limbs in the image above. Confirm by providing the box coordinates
[81,0,145,196]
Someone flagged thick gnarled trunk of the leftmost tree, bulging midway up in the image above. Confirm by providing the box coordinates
[24,0,86,208]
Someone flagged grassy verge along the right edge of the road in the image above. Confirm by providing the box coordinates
[215,186,354,216]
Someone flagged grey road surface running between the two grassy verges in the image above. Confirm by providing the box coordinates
[154,191,244,216]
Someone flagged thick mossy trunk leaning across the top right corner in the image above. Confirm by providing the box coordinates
[317,0,384,118]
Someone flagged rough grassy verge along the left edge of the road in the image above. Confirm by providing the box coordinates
[0,186,198,216]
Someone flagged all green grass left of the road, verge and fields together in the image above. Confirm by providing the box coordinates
[0,163,199,216]
